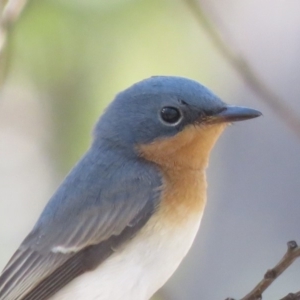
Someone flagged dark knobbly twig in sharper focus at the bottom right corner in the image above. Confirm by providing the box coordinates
[226,241,300,300]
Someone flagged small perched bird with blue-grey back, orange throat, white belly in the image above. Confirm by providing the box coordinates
[0,76,261,300]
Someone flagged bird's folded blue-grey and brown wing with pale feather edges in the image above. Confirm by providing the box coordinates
[0,157,160,300]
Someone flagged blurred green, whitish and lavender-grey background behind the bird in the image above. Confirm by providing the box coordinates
[0,0,300,300]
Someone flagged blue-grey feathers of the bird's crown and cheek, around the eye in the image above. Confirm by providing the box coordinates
[94,76,226,145]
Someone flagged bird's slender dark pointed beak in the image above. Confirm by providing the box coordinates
[208,105,262,123]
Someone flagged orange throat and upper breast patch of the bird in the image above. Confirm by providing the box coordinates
[138,123,226,224]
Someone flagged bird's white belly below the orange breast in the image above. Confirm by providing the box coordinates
[51,213,202,300]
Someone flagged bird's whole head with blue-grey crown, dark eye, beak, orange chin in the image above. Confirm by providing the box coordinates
[94,76,261,169]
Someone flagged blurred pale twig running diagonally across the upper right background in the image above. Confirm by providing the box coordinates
[184,0,300,138]
